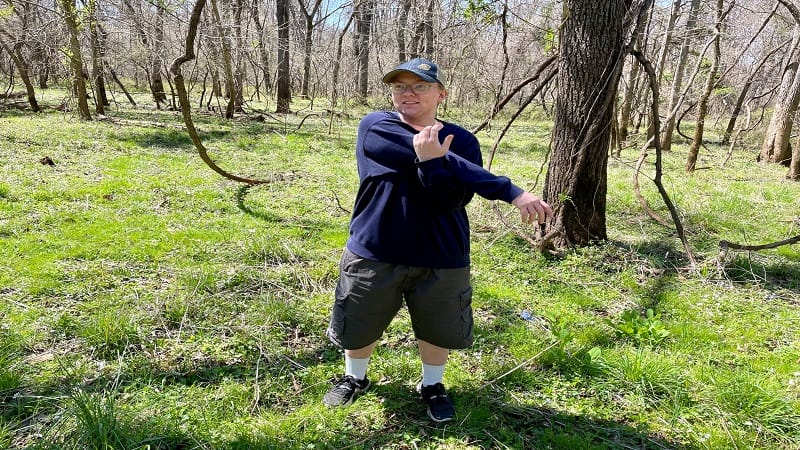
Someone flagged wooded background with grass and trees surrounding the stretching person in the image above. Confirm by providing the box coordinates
[0,0,800,448]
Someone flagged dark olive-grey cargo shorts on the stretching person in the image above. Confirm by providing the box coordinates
[327,249,473,350]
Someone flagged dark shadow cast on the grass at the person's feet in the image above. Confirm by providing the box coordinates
[353,382,689,450]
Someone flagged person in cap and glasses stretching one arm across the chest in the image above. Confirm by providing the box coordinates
[323,58,553,422]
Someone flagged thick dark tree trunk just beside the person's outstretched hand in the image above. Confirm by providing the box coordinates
[544,0,630,247]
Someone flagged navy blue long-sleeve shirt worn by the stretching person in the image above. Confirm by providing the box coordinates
[347,111,523,268]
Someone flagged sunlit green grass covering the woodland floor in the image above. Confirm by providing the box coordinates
[0,90,800,449]
